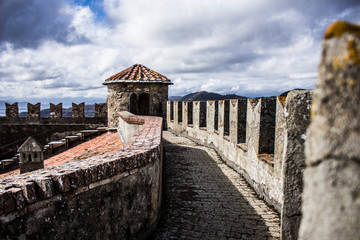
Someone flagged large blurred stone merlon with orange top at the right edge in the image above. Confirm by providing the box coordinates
[299,22,360,239]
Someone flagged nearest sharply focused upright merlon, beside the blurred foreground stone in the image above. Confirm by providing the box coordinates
[281,91,312,240]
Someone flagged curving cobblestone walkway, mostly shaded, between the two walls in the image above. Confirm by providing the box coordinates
[151,132,280,239]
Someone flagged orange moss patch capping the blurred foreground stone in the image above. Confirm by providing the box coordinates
[324,21,360,39]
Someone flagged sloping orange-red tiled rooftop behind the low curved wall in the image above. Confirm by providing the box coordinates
[0,133,124,178]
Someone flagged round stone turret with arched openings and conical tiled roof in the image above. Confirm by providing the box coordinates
[103,64,172,127]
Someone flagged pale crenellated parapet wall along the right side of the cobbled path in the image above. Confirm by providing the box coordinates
[167,91,312,239]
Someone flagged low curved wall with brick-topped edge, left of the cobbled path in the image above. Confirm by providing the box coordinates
[0,113,162,239]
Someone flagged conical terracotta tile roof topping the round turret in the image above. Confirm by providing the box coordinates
[103,64,172,85]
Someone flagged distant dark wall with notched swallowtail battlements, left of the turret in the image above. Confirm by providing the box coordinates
[0,103,107,159]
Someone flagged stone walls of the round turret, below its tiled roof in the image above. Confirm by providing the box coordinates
[107,83,168,127]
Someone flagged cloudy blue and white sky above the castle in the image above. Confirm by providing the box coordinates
[0,0,360,105]
